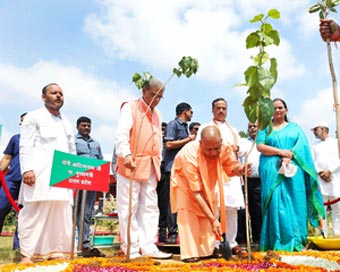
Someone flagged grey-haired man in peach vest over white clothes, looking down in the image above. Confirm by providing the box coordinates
[115,78,172,259]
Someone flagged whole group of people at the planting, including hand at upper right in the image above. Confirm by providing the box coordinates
[0,20,340,263]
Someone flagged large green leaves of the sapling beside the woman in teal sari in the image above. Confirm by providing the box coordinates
[240,9,280,129]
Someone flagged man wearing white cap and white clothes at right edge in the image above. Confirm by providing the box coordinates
[311,121,340,236]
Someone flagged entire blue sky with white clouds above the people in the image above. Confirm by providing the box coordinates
[0,0,340,158]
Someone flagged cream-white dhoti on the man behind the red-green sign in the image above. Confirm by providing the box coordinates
[18,201,72,261]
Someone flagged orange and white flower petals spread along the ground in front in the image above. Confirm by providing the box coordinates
[0,250,340,272]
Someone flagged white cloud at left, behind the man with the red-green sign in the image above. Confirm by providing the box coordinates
[0,61,135,151]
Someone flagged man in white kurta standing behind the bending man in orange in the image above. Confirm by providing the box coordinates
[196,98,245,255]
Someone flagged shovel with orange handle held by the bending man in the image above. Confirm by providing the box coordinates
[218,172,232,260]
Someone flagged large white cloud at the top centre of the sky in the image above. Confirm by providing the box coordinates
[85,0,308,82]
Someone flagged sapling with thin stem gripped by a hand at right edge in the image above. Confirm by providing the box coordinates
[309,0,340,157]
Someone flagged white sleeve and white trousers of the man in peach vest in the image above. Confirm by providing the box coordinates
[115,103,159,258]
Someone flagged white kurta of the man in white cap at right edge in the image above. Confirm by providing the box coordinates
[312,137,340,197]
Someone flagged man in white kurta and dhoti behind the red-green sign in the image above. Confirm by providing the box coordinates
[18,83,75,263]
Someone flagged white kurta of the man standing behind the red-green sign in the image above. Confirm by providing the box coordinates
[19,108,76,204]
